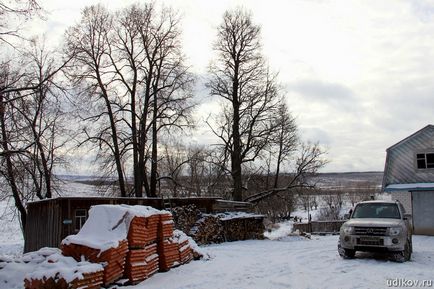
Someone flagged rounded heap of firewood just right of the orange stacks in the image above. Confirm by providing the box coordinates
[189,215,224,244]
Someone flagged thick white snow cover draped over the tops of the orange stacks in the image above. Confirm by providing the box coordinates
[62,205,170,252]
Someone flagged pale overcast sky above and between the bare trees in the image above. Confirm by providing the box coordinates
[28,0,434,172]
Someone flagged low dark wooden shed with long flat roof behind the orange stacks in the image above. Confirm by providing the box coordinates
[24,197,252,252]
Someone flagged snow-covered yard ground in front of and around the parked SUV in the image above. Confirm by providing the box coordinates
[127,236,434,289]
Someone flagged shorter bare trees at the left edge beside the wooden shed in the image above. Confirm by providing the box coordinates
[0,40,68,228]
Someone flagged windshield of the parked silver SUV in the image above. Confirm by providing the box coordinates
[352,203,401,219]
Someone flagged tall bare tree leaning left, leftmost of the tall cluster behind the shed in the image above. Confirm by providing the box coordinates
[66,5,127,197]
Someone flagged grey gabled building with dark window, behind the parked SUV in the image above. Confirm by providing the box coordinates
[383,125,434,235]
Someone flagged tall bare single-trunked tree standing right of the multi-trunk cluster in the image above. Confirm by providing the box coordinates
[207,9,278,201]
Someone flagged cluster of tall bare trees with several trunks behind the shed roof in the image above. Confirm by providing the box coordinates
[68,3,193,197]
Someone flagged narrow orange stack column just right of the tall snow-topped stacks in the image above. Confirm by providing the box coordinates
[158,213,179,271]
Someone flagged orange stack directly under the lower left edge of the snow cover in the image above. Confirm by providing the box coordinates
[62,240,128,286]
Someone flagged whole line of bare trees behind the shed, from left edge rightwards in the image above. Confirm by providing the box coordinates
[0,0,326,231]
